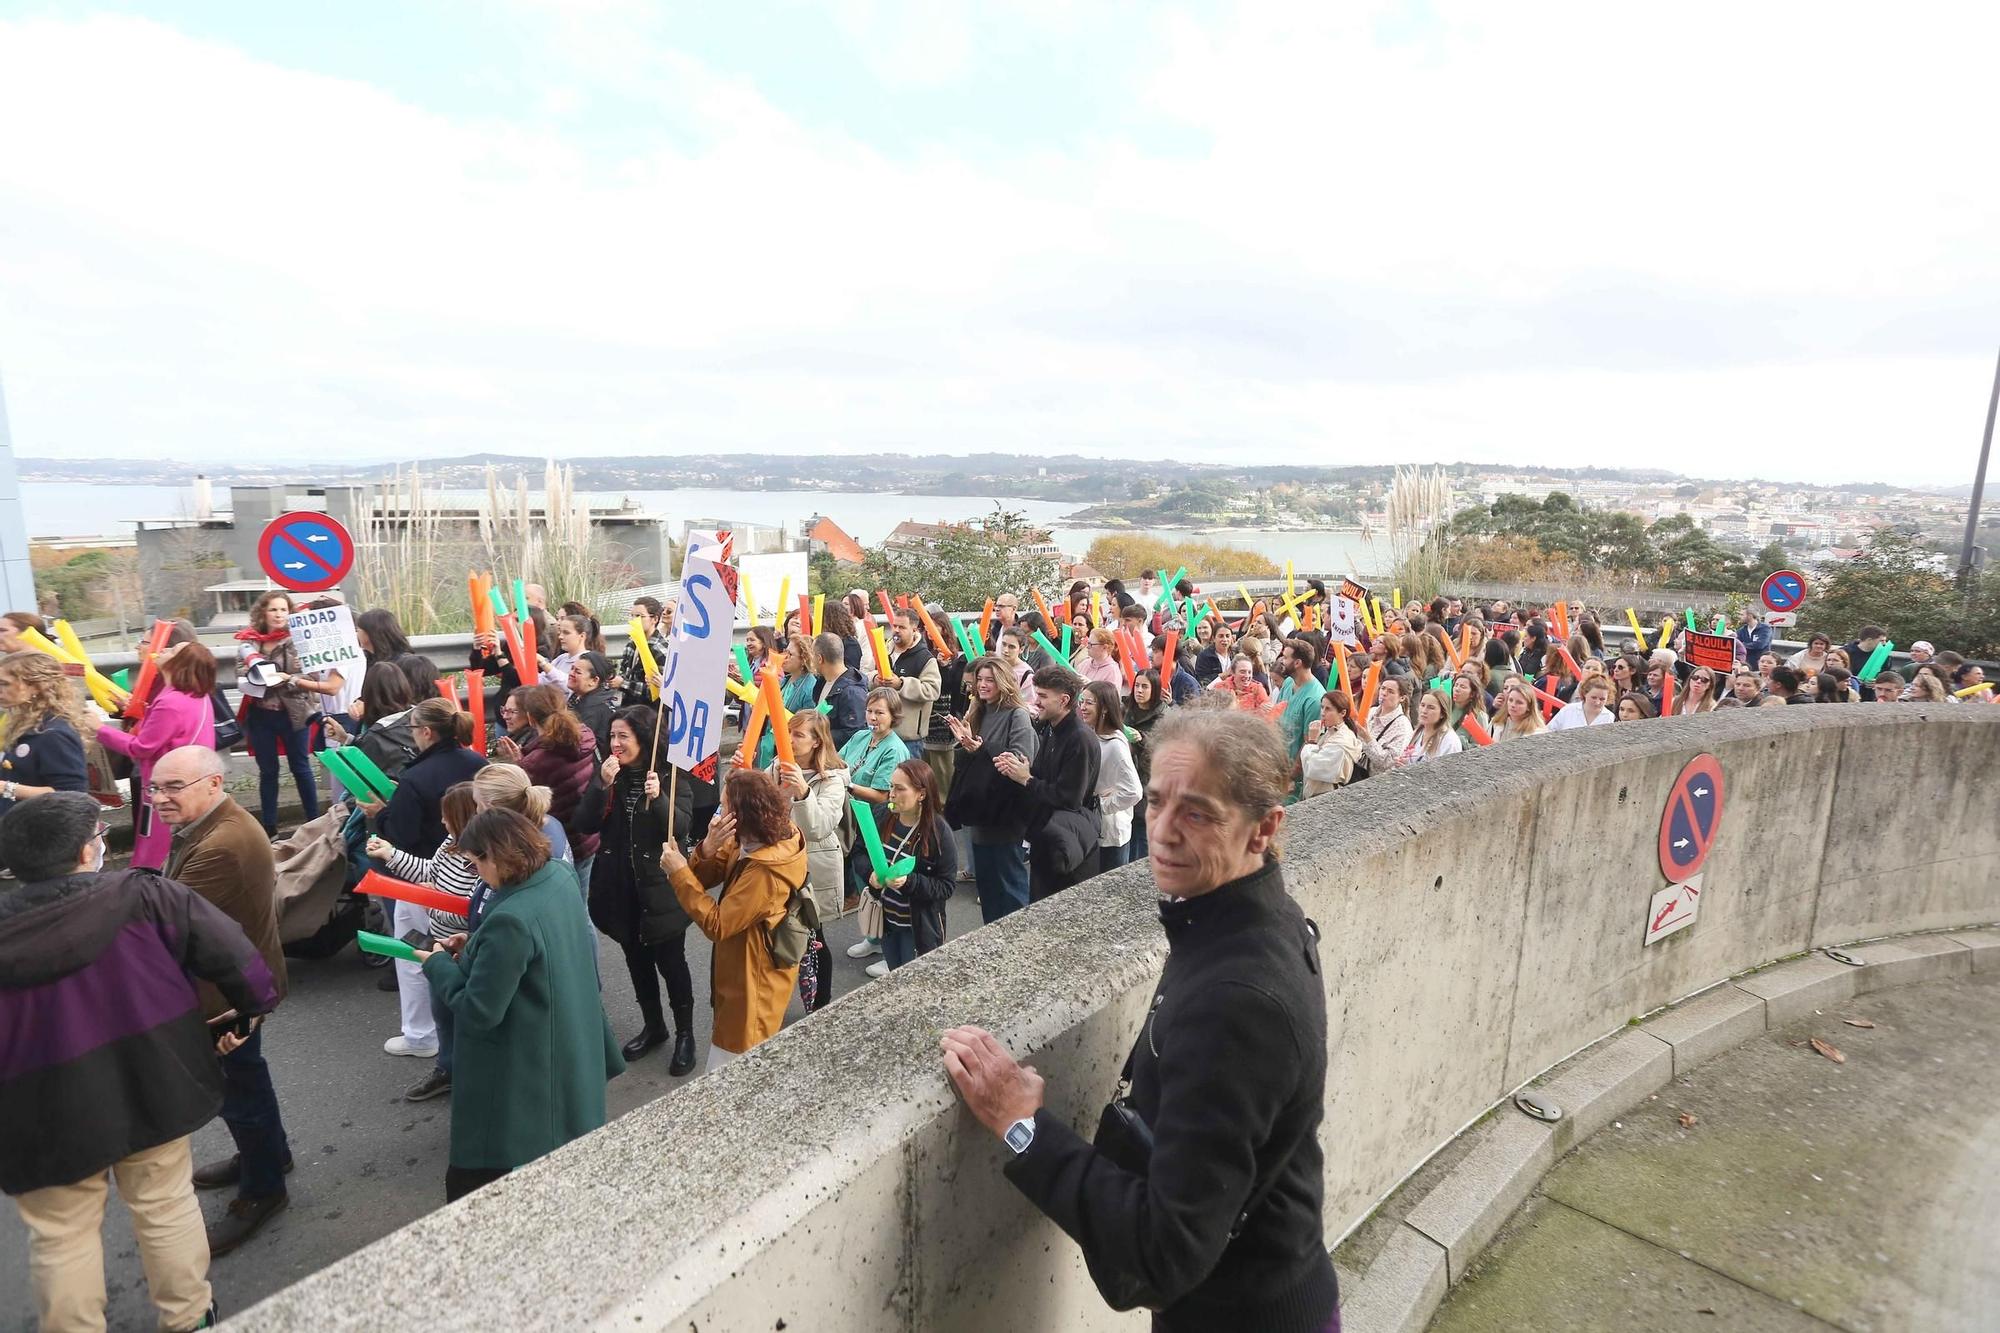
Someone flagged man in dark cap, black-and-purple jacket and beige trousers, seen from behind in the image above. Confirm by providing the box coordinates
[0,793,278,1329]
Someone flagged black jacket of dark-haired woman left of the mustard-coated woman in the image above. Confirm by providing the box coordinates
[574,765,694,945]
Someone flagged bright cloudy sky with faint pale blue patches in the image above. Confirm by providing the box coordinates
[0,0,2000,484]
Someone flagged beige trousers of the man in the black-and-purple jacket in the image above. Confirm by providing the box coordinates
[14,1139,214,1333]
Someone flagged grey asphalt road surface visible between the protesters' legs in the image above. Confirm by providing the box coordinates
[0,852,980,1333]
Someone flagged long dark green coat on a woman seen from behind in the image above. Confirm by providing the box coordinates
[424,861,624,1169]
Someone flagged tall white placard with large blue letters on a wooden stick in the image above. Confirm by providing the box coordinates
[660,532,736,783]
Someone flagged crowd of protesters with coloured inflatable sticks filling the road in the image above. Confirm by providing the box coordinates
[0,580,1990,1329]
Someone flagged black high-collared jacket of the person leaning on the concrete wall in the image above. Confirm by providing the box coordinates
[1006,861,1338,1333]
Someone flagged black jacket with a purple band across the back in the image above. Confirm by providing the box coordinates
[0,871,278,1195]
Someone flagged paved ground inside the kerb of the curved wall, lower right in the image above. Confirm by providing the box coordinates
[1430,975,2000,1333]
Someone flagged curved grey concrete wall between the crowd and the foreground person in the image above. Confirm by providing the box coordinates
[238,705,2000,1331]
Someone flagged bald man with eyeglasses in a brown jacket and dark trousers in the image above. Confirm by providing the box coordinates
[146,745,292,1257]
